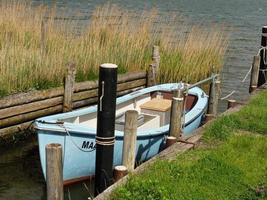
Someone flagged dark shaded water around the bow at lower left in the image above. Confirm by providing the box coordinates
[0,133,93,200]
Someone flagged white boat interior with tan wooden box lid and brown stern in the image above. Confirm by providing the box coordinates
[63,91,197,131]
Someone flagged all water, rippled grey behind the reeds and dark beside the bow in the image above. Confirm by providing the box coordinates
[0,0,267,200]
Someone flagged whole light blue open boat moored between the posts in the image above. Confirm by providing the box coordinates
[34,83,208,184]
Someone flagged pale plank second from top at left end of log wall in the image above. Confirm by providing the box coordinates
[0,96,63,119]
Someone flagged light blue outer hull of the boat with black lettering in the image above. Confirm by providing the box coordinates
[35,83,207,183]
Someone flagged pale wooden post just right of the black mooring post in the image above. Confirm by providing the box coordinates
[122,110,138,172]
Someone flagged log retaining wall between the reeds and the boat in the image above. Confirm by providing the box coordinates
[0,71,151,144]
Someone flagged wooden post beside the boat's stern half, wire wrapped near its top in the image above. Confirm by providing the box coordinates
[169,90,184,139]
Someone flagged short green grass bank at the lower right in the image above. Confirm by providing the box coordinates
[111,91,267,200]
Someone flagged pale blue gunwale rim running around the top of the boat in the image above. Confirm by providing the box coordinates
[34,83,208,138]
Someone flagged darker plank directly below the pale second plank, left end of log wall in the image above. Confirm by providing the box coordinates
[0,105,63,128]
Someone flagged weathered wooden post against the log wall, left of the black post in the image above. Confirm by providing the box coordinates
[63,63,76,112]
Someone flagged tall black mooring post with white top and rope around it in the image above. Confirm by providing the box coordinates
[95,63,118,196]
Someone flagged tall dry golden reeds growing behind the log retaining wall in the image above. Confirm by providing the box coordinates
[0,1,227,96]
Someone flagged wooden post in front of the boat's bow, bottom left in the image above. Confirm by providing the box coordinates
[45,144,64,200]
